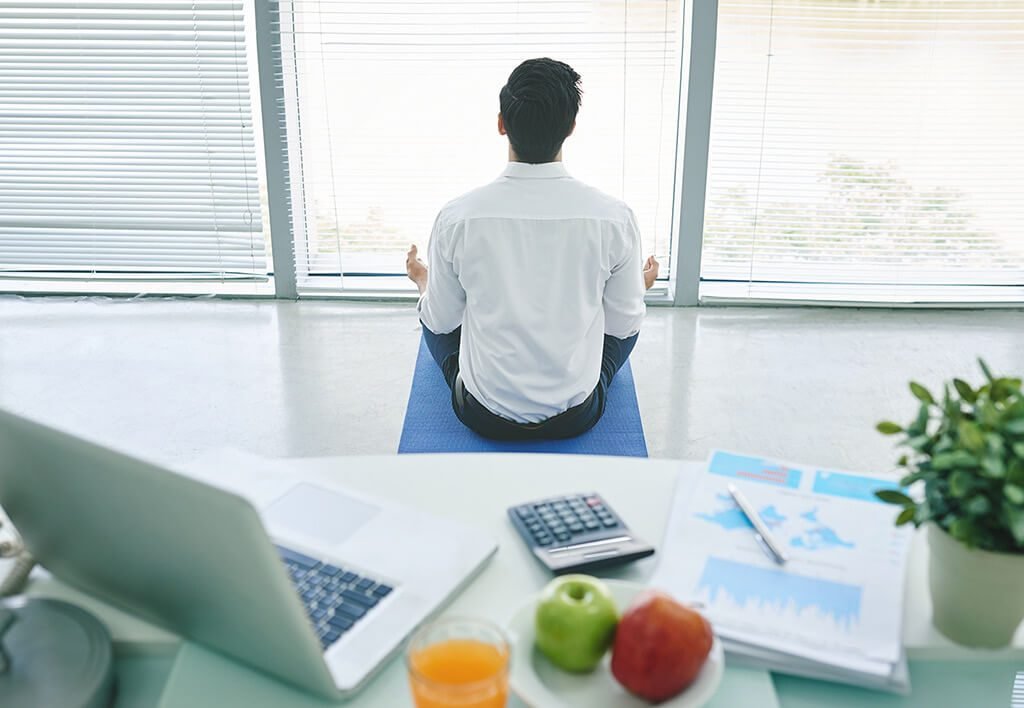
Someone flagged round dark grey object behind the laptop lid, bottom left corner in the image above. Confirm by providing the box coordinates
[0,599,114,708]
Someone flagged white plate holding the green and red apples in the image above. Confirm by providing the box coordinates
[508,580,725,708]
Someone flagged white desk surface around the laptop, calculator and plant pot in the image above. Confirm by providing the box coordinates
[14,451,1024,708]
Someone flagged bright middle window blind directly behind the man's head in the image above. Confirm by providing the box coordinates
[278,0,682,287]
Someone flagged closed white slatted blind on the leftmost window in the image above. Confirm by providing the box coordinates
[0,0,267,277]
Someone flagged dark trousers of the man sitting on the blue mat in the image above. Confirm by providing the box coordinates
[421,323,639,441]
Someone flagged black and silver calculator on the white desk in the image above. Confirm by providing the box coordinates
[509,493,654,575]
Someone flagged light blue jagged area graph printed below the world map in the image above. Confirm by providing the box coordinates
[697,556,862,627]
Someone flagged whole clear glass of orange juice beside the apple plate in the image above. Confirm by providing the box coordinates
[406,618,509,708]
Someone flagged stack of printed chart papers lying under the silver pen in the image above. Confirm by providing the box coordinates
[651,452,911,691]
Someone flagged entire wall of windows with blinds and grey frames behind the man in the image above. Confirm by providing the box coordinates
[0,0,1024,304]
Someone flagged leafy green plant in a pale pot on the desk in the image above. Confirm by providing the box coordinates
[877,360,1024,648]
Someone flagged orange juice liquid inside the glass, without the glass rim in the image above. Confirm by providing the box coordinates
[409,638,509,708]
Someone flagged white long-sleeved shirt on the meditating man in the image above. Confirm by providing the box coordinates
[419,162,645,422]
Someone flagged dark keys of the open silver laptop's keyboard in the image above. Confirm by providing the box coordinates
[276,546,392,651]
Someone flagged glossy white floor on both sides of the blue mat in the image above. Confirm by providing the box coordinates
[0,296,1024,469]
